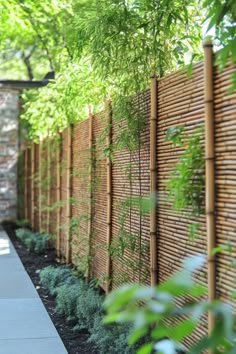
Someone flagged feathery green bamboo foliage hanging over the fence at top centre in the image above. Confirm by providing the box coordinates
[75,0,201,95]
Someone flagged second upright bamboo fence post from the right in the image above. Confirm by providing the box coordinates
[150,75,157,286]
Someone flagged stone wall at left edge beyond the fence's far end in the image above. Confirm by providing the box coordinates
[0,91,19,222]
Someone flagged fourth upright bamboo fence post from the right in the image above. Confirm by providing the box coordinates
[86,108,93,280]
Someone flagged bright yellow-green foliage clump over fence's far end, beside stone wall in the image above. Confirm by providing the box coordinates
[21,59,104,140]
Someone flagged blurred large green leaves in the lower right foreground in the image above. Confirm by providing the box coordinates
[105,256,236,354]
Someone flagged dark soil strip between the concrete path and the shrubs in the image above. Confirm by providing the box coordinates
[3,223,98,354]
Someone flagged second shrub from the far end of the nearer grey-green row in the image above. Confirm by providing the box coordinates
[56,280,82,321]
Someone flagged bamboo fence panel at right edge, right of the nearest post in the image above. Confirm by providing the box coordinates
[214,65,236,306]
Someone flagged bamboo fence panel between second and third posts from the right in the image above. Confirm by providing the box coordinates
[111,90,150,288]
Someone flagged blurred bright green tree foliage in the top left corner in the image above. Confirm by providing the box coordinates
[0,0,73,79]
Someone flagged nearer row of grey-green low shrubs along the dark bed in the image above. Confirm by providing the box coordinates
[40,266,134,354]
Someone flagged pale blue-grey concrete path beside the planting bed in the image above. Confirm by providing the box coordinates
[0,230,67,354]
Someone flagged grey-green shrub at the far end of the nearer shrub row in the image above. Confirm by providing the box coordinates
[39,266,75,296]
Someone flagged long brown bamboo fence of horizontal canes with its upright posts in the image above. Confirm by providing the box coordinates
[19,51,236,346]
